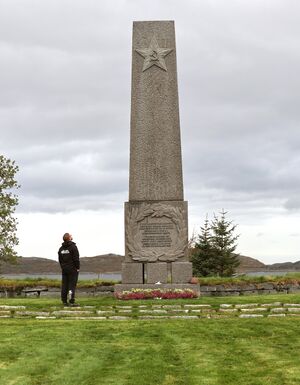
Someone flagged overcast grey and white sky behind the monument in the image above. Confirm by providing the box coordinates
[0,0,300,263]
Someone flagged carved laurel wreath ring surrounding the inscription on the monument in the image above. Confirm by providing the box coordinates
[126,203,187,262]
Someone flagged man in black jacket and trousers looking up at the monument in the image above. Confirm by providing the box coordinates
[58,233,80,306]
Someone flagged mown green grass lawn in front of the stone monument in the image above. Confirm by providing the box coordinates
[0,294,300,385]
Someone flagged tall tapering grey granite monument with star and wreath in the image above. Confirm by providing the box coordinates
[122,21,192,285]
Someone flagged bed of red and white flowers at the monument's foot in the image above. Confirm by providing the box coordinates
[115,289,198,300]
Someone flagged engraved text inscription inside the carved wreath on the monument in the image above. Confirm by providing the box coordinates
[140,223,175,247]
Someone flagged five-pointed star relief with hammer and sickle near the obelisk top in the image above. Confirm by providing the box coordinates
[136,36,173,71]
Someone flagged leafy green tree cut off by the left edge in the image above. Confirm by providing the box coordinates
[0,155,19,262]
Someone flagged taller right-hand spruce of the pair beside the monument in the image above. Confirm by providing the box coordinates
[210,210,240,277]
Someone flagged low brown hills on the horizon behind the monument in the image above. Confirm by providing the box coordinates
[0,254,300,274]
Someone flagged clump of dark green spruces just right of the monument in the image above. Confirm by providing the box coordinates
[191,210,239,277]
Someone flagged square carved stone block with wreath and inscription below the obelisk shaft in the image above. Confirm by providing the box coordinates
[125,201,188,262]
